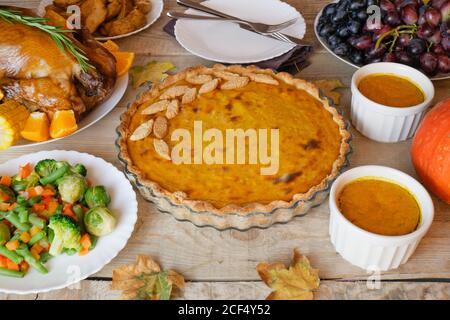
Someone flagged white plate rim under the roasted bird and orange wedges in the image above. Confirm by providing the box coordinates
[9,74,129,150]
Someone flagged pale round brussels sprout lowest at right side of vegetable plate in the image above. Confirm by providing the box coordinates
[84,207,116,237]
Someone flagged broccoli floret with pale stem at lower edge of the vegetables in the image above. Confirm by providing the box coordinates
[48,214,81,256]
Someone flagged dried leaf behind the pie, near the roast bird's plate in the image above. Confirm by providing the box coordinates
[130,61,175,88]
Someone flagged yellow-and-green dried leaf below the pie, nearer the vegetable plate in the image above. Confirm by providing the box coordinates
[111,255,184,300]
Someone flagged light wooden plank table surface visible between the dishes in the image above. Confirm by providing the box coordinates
[0,0,450,299]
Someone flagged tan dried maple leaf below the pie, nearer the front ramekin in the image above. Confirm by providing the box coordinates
[256,250,320,300]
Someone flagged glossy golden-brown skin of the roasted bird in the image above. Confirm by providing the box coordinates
[0,8,116,118]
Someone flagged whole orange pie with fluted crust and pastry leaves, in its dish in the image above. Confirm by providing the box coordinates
[116,65,351,230]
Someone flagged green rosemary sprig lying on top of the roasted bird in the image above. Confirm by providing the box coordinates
[0,9,94,72]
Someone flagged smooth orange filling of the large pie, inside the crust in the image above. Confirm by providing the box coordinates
[127,80,342,208]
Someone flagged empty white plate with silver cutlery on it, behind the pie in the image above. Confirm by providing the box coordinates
[175,0,306,64]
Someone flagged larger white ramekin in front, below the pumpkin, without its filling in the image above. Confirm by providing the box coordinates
[329,166,434,271]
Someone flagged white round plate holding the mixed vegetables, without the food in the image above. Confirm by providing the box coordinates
[0,150,137,294]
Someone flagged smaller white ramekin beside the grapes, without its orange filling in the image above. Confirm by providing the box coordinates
[351,62,434,142]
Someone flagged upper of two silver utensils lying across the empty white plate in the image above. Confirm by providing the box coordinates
[177,0,298,34]
